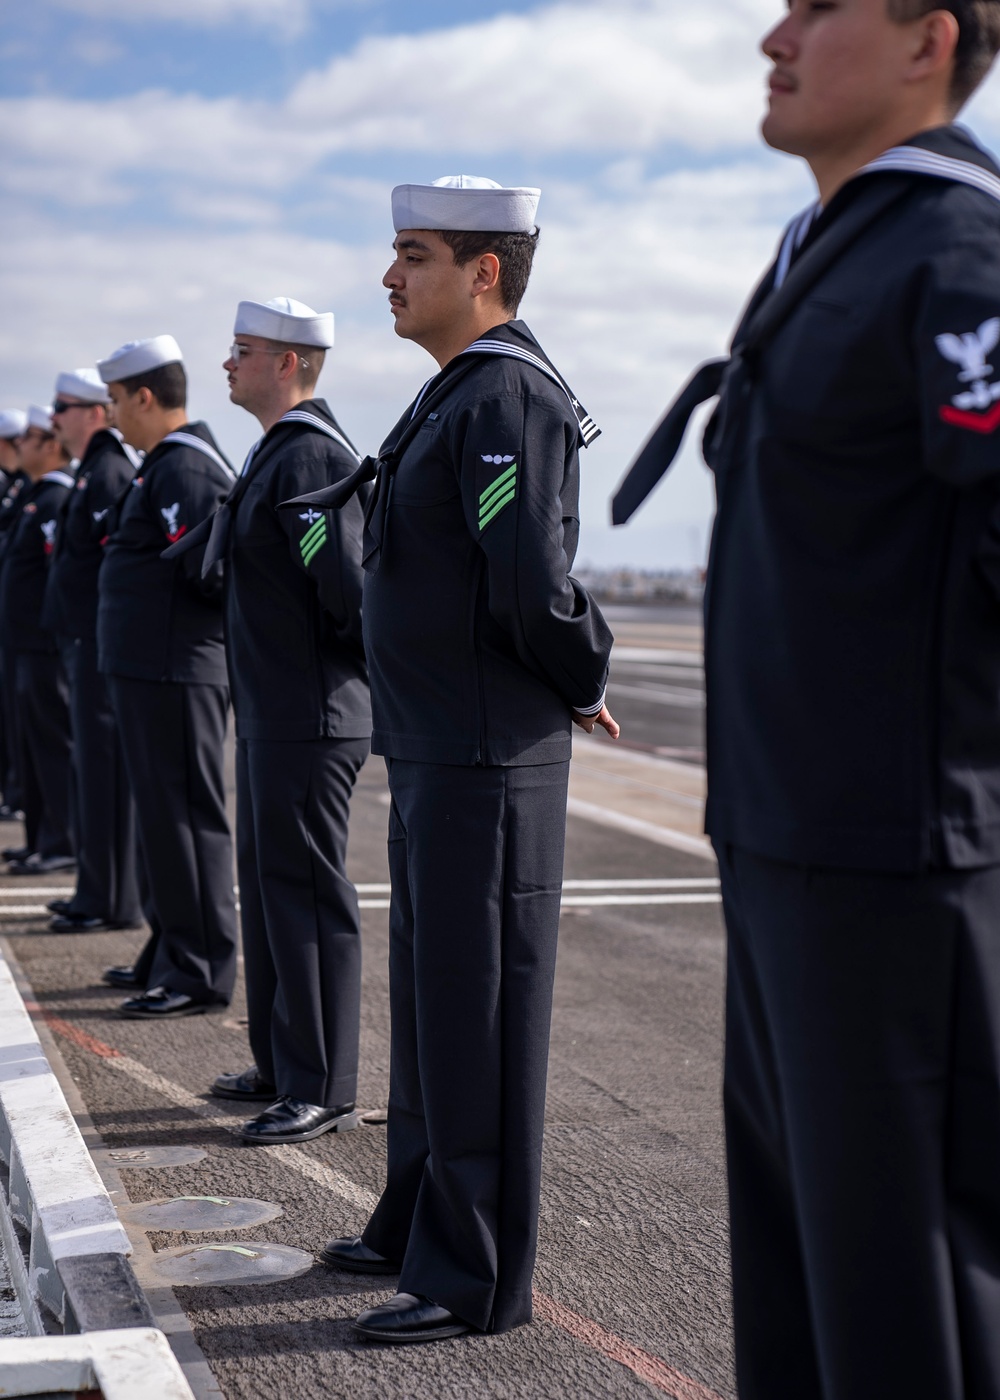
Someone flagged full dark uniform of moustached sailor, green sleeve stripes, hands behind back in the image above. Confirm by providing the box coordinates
[354,321,611,1331]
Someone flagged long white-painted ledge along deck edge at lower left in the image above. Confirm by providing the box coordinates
[0,953,132,1321]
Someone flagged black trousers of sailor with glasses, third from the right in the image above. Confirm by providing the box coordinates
[237,739,371,1107]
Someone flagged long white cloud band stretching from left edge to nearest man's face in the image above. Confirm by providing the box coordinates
[0,0,772,219]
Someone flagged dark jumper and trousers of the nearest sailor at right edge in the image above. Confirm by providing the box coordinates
[616,127,1000,1400]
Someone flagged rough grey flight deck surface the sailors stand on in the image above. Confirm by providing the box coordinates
[0,609,734,1400]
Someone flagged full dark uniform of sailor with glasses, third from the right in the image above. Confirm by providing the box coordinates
[223,399,371,1107]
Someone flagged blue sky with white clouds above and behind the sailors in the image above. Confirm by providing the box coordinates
[0,0,1000,567]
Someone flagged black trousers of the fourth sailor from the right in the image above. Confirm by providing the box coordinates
[105,676,237,1005]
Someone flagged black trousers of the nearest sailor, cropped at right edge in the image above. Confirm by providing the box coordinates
[720,847,1000,1400]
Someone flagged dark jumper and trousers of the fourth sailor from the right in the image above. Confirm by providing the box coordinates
[97,423,237,1004]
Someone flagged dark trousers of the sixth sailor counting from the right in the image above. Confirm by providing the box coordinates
[14,651,73,855]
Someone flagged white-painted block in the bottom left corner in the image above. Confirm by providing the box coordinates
[0,1327,193,1400]
